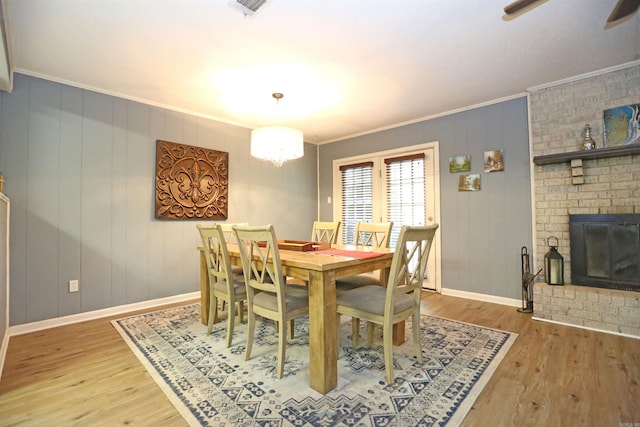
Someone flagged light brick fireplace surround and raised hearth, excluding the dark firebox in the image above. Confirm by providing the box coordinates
[529,61,640,337]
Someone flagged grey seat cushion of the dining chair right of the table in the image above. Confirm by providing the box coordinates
[336,286,413,316]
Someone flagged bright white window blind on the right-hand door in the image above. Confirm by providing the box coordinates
[384,153,426,247]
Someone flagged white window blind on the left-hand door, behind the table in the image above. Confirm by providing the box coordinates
[340,162,373,244]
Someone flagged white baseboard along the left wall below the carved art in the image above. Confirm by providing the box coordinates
[3,291,200,338]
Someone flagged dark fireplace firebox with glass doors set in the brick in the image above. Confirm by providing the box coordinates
[569,214,640,292]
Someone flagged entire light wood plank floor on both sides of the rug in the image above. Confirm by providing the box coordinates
[0,293,640,427]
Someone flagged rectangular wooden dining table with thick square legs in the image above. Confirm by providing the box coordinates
[198,244,404,394]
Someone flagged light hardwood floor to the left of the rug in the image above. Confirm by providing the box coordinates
[0,302,192,426]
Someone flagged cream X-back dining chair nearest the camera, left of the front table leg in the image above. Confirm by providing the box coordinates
[233,225,309,378]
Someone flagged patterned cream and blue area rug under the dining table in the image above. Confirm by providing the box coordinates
[112,304,517,427]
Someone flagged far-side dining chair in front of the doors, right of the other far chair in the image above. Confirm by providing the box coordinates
[336,221,393,344]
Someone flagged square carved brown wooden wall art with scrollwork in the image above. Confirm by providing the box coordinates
[156,140,229,219]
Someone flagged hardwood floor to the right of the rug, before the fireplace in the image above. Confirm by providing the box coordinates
[423,294,640,427]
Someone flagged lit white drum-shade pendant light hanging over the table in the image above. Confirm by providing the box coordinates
[251,93,304,168]
